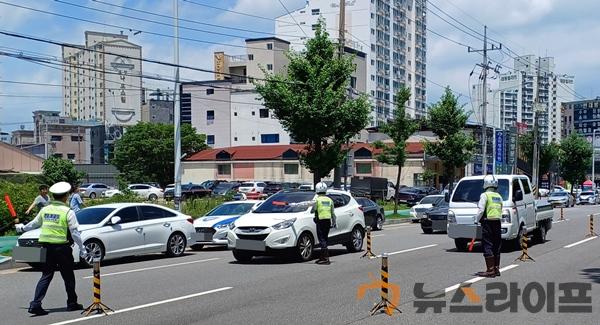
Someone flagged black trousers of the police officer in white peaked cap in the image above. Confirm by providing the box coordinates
[29,244,77,308]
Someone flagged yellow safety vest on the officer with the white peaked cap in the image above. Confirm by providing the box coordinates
[39,202,70,244]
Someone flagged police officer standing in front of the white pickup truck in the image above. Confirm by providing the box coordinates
[477,175,502,278]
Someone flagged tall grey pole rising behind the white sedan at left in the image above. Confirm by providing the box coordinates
[173,0,181,211]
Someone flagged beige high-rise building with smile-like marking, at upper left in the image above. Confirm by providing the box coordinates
[62,31,143,127]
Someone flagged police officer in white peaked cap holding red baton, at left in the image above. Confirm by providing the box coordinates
[16,182,86,316]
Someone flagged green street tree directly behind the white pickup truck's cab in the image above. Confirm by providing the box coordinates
[424,87,475,188]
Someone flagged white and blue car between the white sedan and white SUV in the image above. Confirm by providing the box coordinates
[191,200,263,250]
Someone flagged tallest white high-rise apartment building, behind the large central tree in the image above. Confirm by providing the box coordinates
[275,0,427,126]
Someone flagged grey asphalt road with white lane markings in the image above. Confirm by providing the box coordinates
[0,206,600,325]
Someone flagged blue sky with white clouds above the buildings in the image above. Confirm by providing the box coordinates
[0,0,600,131]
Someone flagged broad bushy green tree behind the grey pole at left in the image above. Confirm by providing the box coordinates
[111,123,207,186]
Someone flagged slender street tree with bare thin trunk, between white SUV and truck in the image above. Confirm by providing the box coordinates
[375,87,419,213]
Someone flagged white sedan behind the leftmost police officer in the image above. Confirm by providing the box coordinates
[13,203,195,266]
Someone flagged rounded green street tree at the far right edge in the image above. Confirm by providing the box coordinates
[558,133,592,192]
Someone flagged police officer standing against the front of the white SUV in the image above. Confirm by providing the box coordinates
[315,182,335,265]
